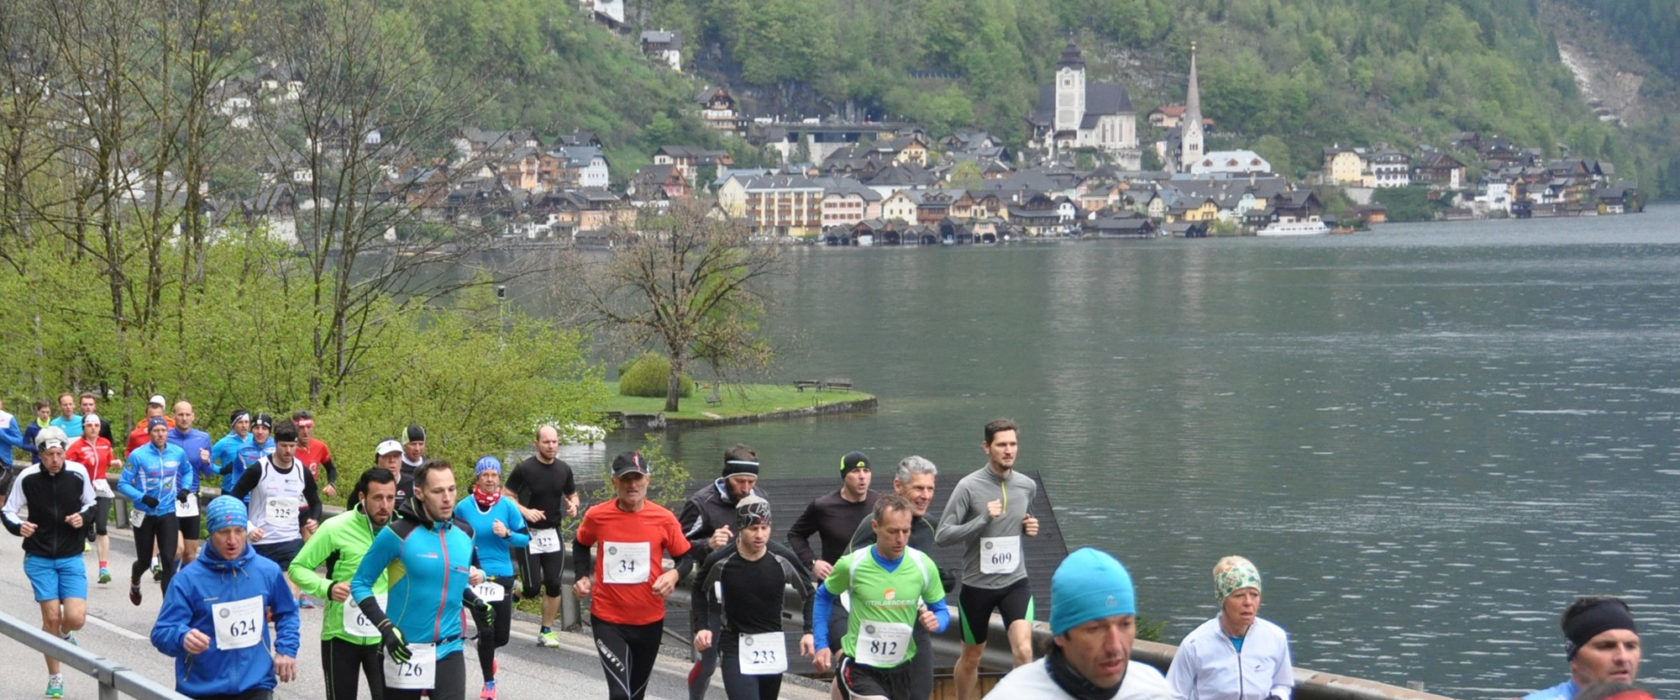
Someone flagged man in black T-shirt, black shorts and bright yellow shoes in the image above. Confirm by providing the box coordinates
[507,425,578,648]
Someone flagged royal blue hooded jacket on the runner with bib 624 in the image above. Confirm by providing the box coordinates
[150,540,297,698]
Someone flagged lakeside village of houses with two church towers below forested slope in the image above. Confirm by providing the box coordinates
[206,11,1643,247]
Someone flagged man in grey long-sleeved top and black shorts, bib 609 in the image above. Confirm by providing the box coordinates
[934,418,1038,700]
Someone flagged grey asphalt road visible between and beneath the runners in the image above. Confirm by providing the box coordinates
[0,530,828,700]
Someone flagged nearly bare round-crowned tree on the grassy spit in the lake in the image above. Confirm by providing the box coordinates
[580,200,780,411]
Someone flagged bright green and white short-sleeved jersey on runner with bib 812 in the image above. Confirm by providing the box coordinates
[823,547,946,668]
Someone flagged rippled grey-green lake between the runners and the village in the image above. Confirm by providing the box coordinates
[575,206,1680,698]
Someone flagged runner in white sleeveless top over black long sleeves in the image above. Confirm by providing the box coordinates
[228,420,321,608]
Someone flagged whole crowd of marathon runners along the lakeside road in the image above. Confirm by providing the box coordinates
[0,394,1640,700]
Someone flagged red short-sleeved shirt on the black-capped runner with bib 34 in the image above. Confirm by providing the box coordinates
[578,500,689,624]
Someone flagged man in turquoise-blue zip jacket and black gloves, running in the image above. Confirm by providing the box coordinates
[349,460,496,700]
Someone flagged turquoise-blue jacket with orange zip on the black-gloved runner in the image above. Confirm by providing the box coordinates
[349,499,472,658]
